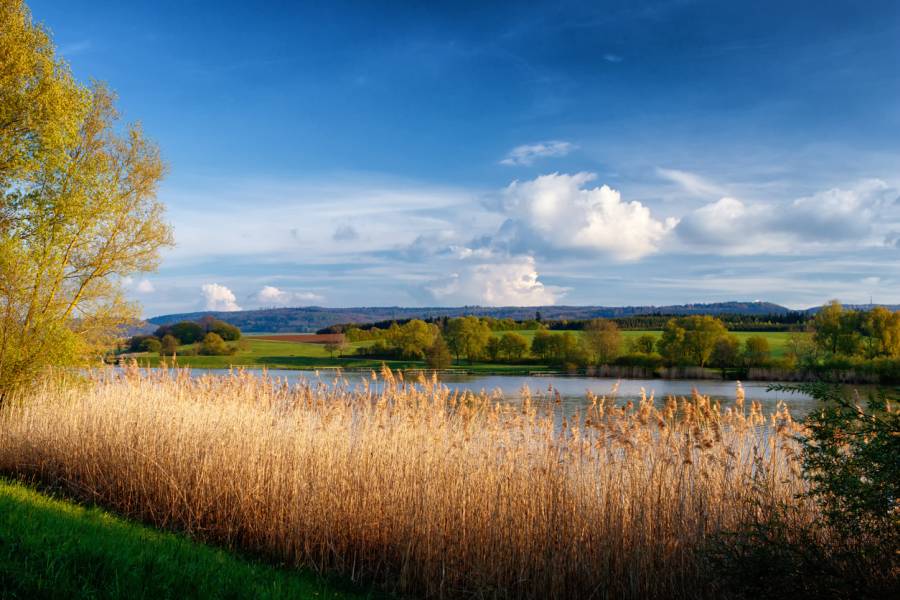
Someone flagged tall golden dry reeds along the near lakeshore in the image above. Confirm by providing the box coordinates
[0,369,816,598]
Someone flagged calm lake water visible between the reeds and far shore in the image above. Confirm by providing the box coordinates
[179,369,817,419]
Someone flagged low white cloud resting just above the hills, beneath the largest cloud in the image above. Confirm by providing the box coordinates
[427,256,564,306]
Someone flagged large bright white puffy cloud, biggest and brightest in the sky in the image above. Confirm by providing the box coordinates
[500,173,677,260]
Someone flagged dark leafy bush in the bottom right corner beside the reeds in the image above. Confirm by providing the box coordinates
[709,383,900,599]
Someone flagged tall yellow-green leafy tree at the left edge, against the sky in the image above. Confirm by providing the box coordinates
[0,39,172,401]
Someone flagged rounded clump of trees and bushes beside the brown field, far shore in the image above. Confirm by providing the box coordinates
[125,316,241,356]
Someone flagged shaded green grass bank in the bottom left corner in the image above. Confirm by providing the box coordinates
[0,479,365,600]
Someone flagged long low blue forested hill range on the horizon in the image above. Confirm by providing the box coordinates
[142,302,793,333]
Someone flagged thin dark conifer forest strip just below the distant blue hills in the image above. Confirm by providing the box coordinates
[324,311,813,339]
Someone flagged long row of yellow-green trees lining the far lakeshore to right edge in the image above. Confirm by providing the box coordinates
[342,302,900,380]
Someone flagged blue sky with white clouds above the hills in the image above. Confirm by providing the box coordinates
[29,0,900,316]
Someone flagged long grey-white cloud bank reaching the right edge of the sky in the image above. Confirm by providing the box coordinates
[677,180,900,254]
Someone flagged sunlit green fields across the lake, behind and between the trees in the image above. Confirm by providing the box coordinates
[137,330,790,373]
